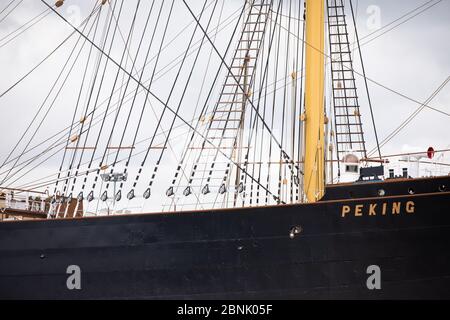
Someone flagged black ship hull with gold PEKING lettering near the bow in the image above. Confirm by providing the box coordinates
[0,177,450,299]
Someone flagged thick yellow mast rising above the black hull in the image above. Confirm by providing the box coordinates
[303,0,325,202]
